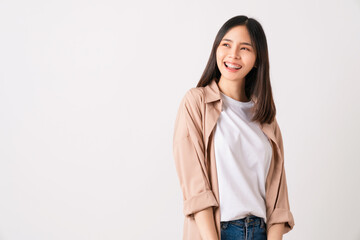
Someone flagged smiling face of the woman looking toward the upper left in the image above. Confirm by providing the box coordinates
[216,26,256,80]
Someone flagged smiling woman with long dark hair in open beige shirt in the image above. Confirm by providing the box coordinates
[173,15,295,240]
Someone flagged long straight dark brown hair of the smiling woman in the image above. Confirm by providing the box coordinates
[196,15,276,124]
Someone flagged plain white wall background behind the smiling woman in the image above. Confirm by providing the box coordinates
[0,0,360,240]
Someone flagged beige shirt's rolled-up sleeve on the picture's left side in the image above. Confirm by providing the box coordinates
[173,89,218,216]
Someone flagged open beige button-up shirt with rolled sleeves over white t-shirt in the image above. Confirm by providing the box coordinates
[173,79,295,240]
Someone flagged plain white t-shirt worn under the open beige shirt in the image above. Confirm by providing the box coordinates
[214,92,272,222]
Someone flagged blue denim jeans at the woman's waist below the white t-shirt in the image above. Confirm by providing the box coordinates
[220,215,267,240]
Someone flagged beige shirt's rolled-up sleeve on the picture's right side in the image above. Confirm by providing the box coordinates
[267,118,295,234]
